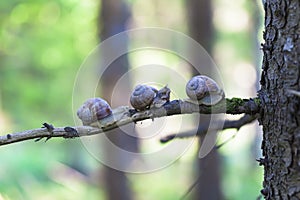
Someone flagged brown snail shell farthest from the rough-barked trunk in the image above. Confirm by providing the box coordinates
[77,98,112,125]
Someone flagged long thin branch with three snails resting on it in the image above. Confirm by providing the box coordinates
[0,98,260,146]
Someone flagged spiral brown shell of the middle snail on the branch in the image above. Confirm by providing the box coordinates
[130,85,157,110]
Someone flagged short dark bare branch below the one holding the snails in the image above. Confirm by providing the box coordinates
[160,114,258,143]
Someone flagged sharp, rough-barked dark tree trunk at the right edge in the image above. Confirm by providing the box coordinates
[259,0,300,200]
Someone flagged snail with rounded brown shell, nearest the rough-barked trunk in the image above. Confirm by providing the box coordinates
[185,75,224,105]
